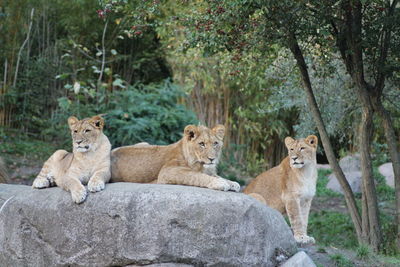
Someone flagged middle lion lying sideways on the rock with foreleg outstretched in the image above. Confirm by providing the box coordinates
[111,125,240,192]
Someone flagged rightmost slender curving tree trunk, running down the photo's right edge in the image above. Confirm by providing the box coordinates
[373,98,400,250]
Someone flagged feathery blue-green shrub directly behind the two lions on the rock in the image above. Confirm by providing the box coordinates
[44,80,196,147]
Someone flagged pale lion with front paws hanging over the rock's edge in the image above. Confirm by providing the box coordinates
[32,115,111,204]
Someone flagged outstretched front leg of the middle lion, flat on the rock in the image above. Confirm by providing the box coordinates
[157,166,239,191]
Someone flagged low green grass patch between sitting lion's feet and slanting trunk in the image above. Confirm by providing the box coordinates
[308,211,358,248]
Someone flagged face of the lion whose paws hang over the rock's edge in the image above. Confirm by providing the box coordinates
[68,116,104,152]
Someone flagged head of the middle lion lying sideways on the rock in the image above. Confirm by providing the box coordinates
[184,125,225,167]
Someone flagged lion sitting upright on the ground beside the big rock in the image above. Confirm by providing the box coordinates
[243,135,318,243]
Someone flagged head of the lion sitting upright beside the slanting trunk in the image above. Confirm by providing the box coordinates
[285,135,318,168]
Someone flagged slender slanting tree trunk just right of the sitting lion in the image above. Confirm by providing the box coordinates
[289,33,362,243]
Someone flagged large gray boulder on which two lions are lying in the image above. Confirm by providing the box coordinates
[0,183,296,266]
